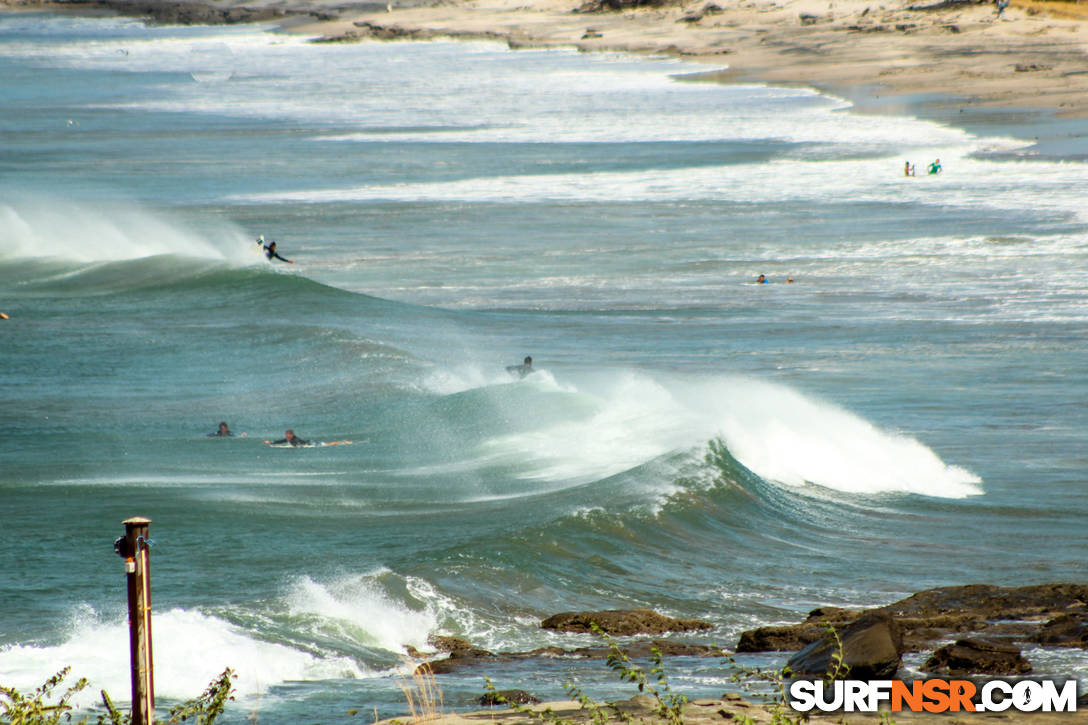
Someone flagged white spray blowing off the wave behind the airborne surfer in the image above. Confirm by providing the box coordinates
[0,197,260,265]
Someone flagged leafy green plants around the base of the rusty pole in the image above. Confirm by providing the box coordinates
[0,667,237,725]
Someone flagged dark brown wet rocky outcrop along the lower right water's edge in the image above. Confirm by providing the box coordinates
[409,585,1088,679]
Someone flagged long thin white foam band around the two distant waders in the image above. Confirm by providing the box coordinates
[227,147,1088,214]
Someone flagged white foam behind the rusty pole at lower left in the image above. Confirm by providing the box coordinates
[0,607,363,706]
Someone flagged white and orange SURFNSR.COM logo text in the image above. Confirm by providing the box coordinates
[789,679,1077,713]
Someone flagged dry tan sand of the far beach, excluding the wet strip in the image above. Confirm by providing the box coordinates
[294,0,1088,118]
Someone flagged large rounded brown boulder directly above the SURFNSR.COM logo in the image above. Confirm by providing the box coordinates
[787,611,903,679]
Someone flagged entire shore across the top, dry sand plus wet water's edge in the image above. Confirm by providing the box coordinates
[8,0,1088,159]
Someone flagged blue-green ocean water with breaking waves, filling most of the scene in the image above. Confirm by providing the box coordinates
[0,13,1088,724]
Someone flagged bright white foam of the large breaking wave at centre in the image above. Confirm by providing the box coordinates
[472,372,982,497]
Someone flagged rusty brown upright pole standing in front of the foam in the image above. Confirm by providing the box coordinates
[118,516,154,725]
